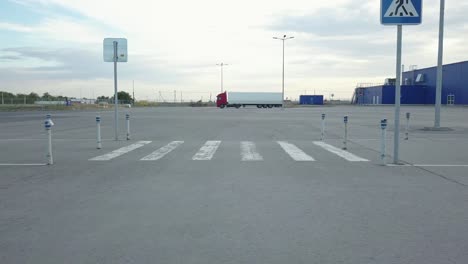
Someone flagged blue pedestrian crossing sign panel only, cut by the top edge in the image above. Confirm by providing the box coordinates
[380,0,422,25]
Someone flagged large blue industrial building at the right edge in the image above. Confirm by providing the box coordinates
[352,61,468,105]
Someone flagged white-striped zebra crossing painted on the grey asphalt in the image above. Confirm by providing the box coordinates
[89,140,369,162]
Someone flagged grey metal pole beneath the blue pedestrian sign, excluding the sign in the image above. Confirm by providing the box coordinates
[393,25,403,164]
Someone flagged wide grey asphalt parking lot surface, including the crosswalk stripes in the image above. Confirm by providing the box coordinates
[0,106,468,264]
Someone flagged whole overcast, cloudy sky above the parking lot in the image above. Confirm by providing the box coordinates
[0,0,468,100]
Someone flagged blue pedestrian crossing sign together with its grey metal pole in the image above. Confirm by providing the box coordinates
[380,0,422,164]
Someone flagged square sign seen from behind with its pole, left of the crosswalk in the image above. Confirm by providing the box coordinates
[104,38,128,140]
